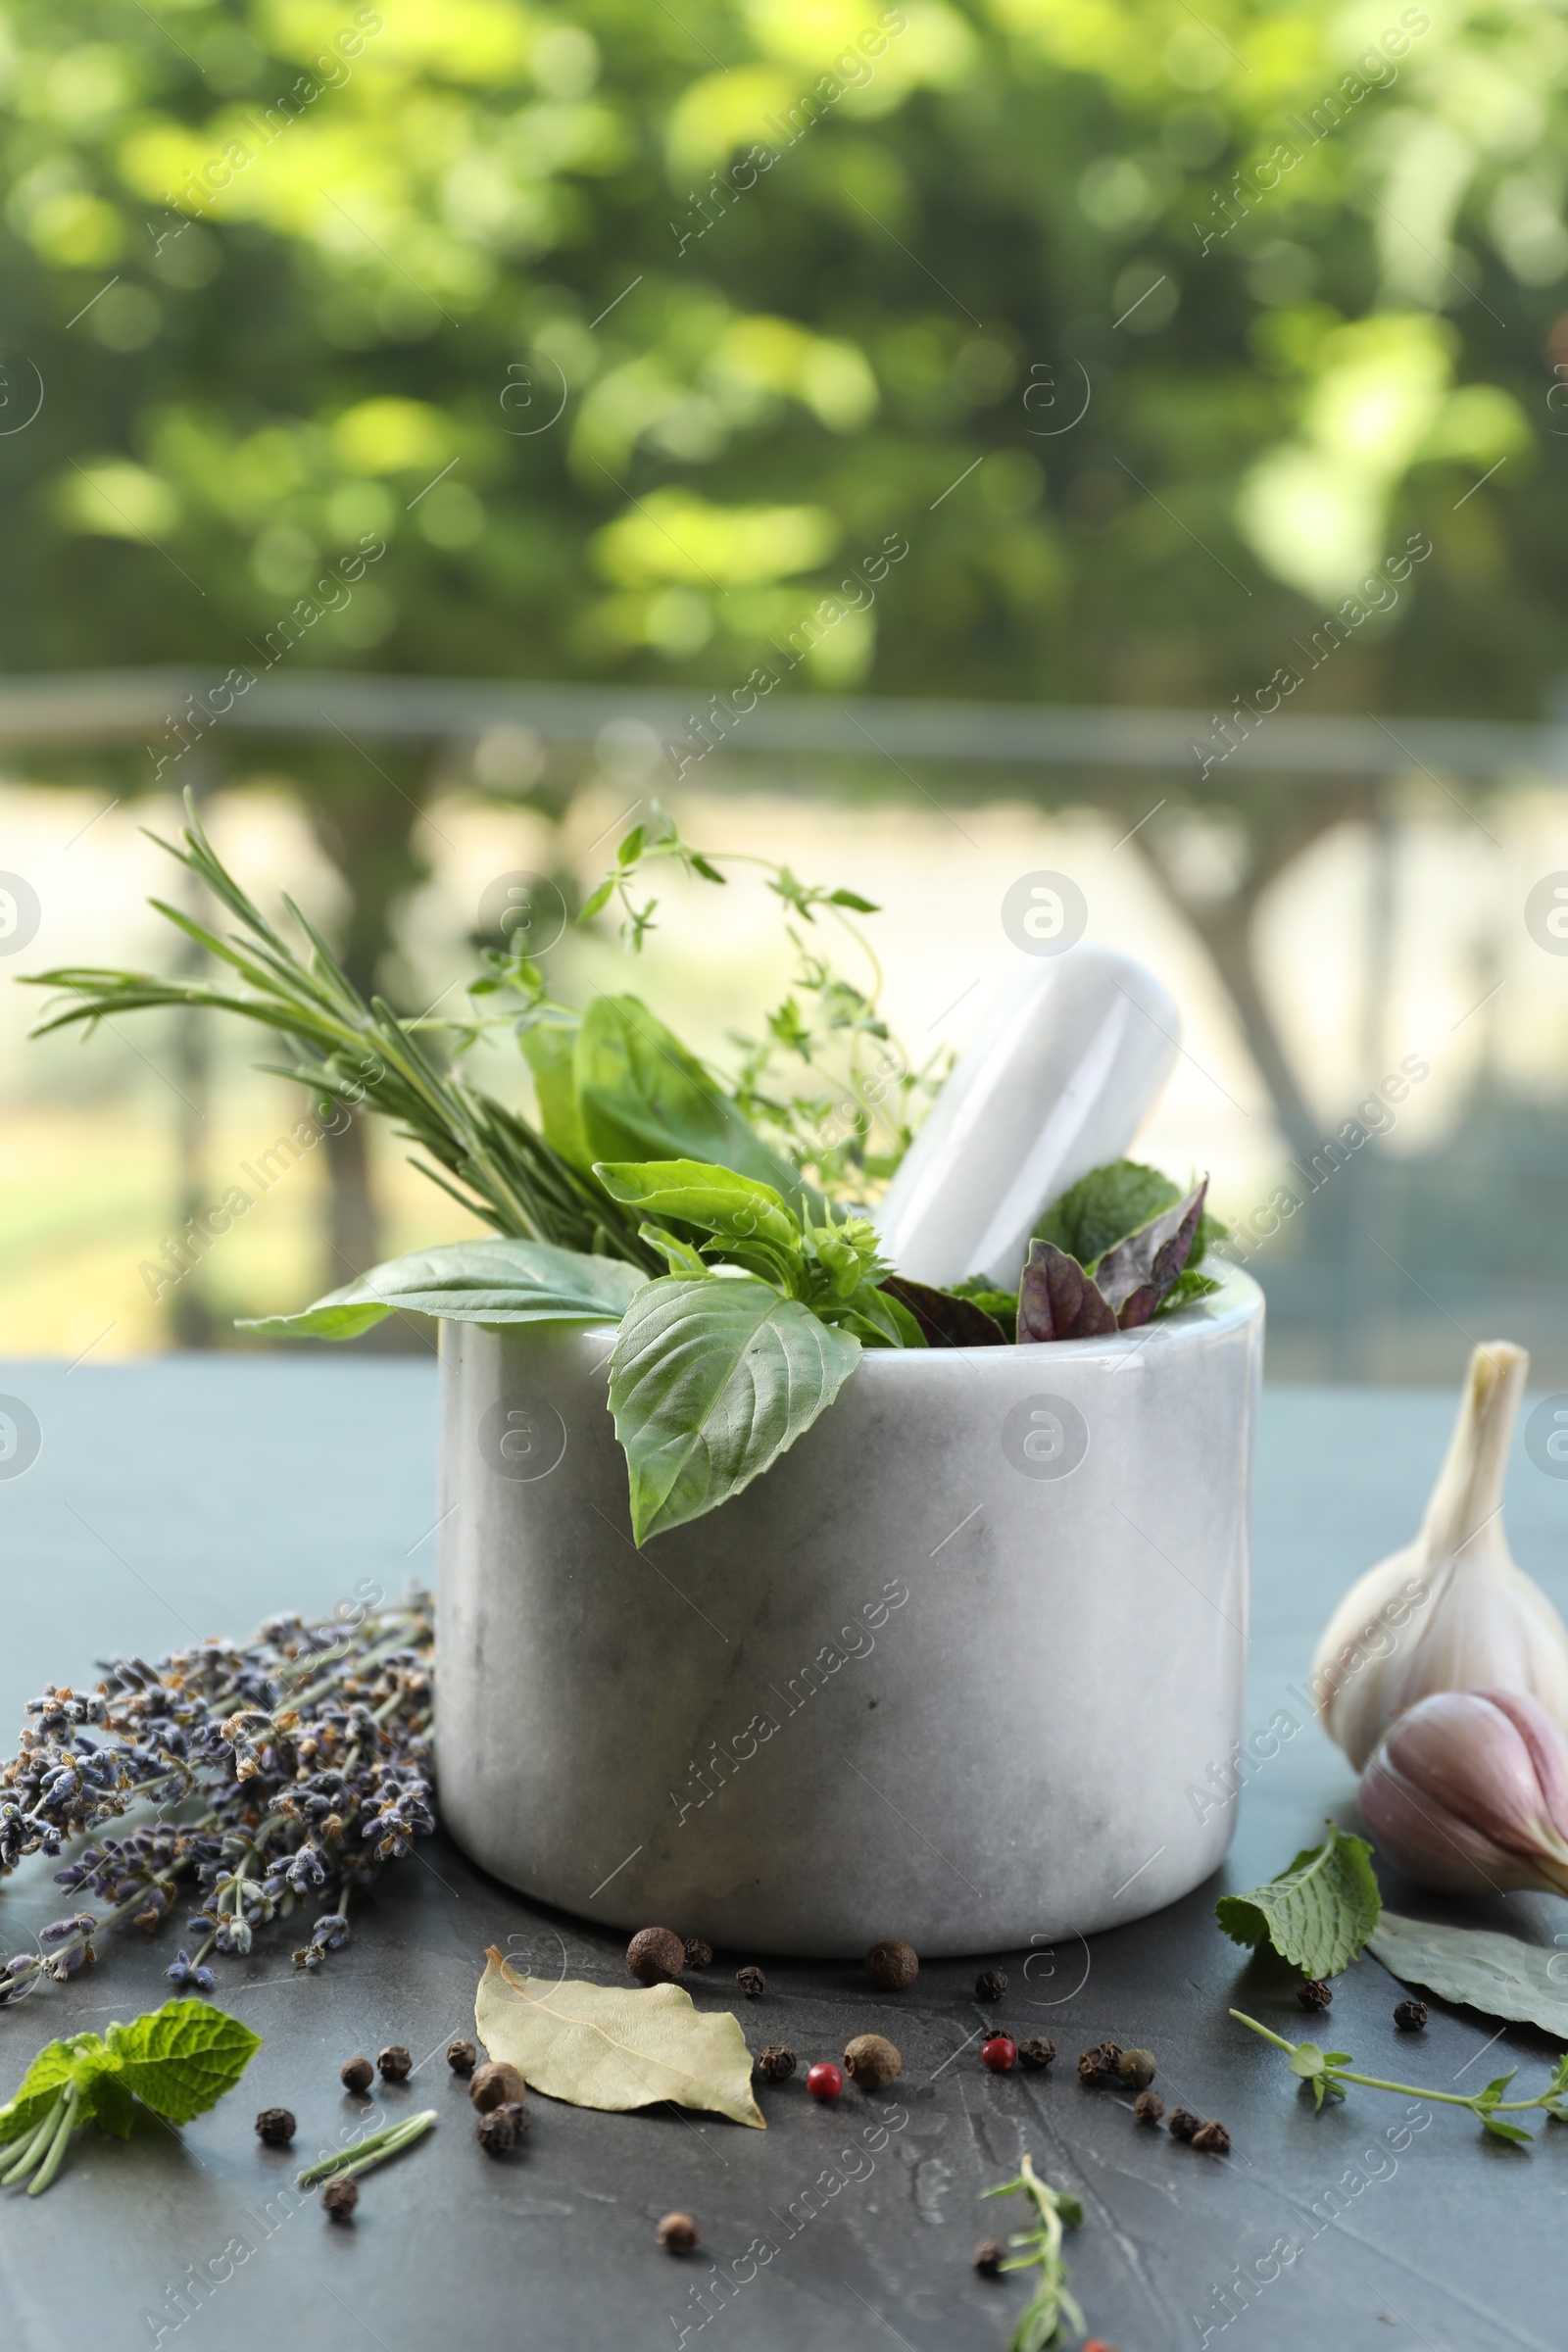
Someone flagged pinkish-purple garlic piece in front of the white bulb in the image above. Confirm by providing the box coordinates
[1361,1691,1568,1895]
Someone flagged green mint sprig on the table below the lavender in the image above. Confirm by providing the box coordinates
[0,2001,261,2197]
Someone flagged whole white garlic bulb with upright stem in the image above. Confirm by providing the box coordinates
[1312,1339,1568,1771]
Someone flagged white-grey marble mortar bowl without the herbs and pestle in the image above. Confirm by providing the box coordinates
[437,1270,1262,1966]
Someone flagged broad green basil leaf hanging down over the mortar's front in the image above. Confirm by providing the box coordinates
[609,1275,860,1543]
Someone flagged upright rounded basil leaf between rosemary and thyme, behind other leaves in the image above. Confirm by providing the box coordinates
[571,998,815,1200]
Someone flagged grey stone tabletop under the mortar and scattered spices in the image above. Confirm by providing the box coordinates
[0,1352,1568,2352]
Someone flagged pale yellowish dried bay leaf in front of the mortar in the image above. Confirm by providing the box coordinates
[475,1945,766,2131]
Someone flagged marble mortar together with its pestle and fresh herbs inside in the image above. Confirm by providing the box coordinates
[30,816,1262,1954]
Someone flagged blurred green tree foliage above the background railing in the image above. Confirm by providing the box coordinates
[0,0,1568,712]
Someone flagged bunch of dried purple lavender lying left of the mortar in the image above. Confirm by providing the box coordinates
[0,1592,435,2001]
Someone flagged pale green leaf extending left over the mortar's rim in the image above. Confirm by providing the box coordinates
[240,1235,649,1339]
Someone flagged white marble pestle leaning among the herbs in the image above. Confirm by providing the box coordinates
[874,946,1180,1292]
